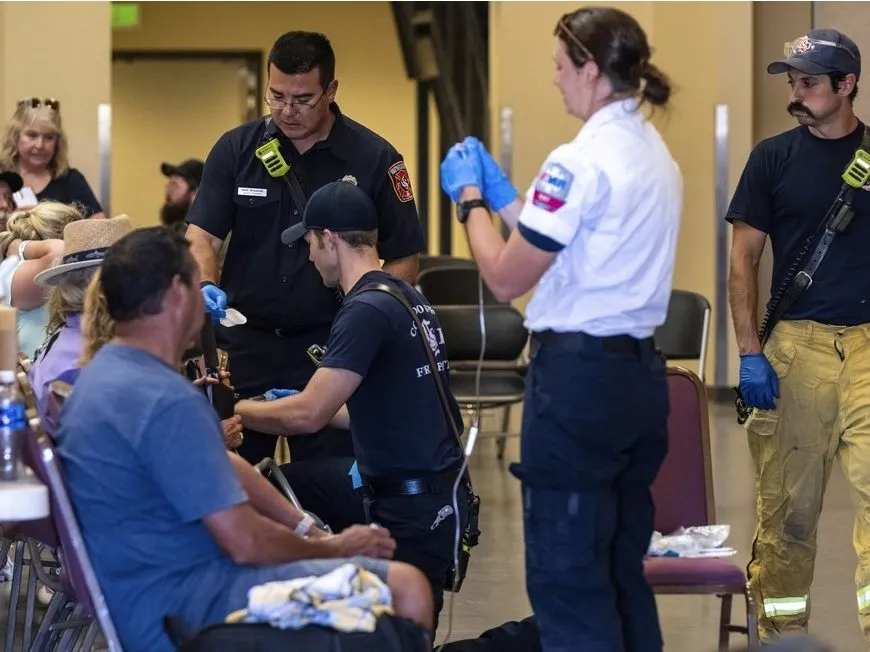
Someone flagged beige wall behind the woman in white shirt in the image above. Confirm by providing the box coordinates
[492,2,753,382]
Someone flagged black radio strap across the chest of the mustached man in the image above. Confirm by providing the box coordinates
[734,126,870,424]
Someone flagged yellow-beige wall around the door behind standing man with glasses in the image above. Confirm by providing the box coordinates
[112,1,440,247]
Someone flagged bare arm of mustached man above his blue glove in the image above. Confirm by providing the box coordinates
[728,222,767,355]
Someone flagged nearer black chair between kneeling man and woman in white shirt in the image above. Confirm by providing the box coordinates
[435,304,529,459]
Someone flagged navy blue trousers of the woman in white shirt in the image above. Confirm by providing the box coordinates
[511,334,668,652]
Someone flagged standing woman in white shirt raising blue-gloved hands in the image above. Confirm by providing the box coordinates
[441,7,682,652]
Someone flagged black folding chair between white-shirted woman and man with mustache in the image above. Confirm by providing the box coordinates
[655,290,711,382]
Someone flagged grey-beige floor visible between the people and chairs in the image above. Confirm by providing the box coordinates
[0,405,867,652]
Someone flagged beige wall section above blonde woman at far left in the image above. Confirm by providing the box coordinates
[0,1,111,204]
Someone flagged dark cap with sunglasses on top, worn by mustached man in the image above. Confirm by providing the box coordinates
[767,29,861,77]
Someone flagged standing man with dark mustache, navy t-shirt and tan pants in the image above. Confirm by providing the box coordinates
[726,29,870,644]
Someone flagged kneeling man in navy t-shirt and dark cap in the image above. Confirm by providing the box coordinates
[236,181,471,620]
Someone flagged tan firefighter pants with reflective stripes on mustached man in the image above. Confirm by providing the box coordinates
[746,321,870,644]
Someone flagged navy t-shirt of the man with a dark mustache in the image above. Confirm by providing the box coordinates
[726,123,870,326]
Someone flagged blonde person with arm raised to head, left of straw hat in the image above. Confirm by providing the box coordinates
[0,202,83,359]
